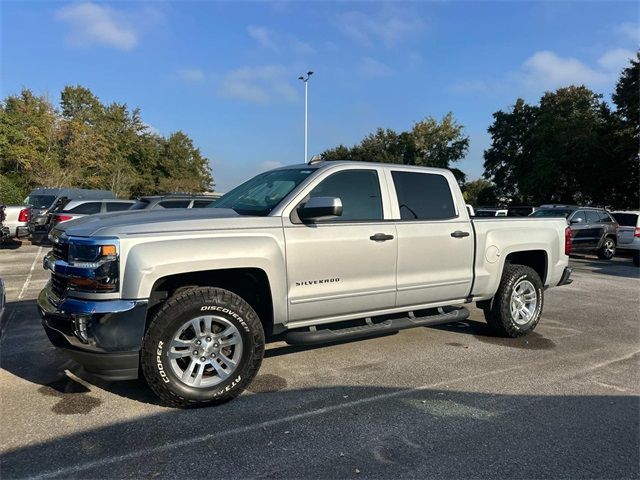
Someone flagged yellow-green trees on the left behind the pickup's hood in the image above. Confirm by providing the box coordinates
[0,86,213,201]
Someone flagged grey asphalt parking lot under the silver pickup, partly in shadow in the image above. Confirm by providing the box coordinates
[0,243,640,478]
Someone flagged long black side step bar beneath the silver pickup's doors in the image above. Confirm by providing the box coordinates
[284,307,469,345]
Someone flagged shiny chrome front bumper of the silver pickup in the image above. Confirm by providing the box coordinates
[38,284,147,380]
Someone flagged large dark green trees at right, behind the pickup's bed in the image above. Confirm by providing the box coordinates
[484,57,640,208]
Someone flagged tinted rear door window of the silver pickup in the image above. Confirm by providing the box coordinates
[391,171,456,220]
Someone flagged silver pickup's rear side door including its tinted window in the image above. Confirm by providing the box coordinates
[390,170,474,307]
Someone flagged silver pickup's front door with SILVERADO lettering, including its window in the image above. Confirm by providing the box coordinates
[284,169,397,321]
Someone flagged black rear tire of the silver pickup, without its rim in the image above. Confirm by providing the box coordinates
[484,263,544,338]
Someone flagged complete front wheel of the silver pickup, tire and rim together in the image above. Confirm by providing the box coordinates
[141,287,264,408]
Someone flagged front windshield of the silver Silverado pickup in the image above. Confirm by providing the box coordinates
[214,168,314,216]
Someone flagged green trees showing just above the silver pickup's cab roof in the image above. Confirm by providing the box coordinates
[321,113,469,183]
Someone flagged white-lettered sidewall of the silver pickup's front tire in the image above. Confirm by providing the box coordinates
[143,296,264,403]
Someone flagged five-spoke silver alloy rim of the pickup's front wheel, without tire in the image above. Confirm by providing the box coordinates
[167,315,242,388]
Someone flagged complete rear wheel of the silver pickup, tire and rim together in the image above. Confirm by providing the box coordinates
[484,264,544,338]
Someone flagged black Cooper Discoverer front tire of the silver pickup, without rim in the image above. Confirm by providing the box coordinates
[140,287,265,408]
